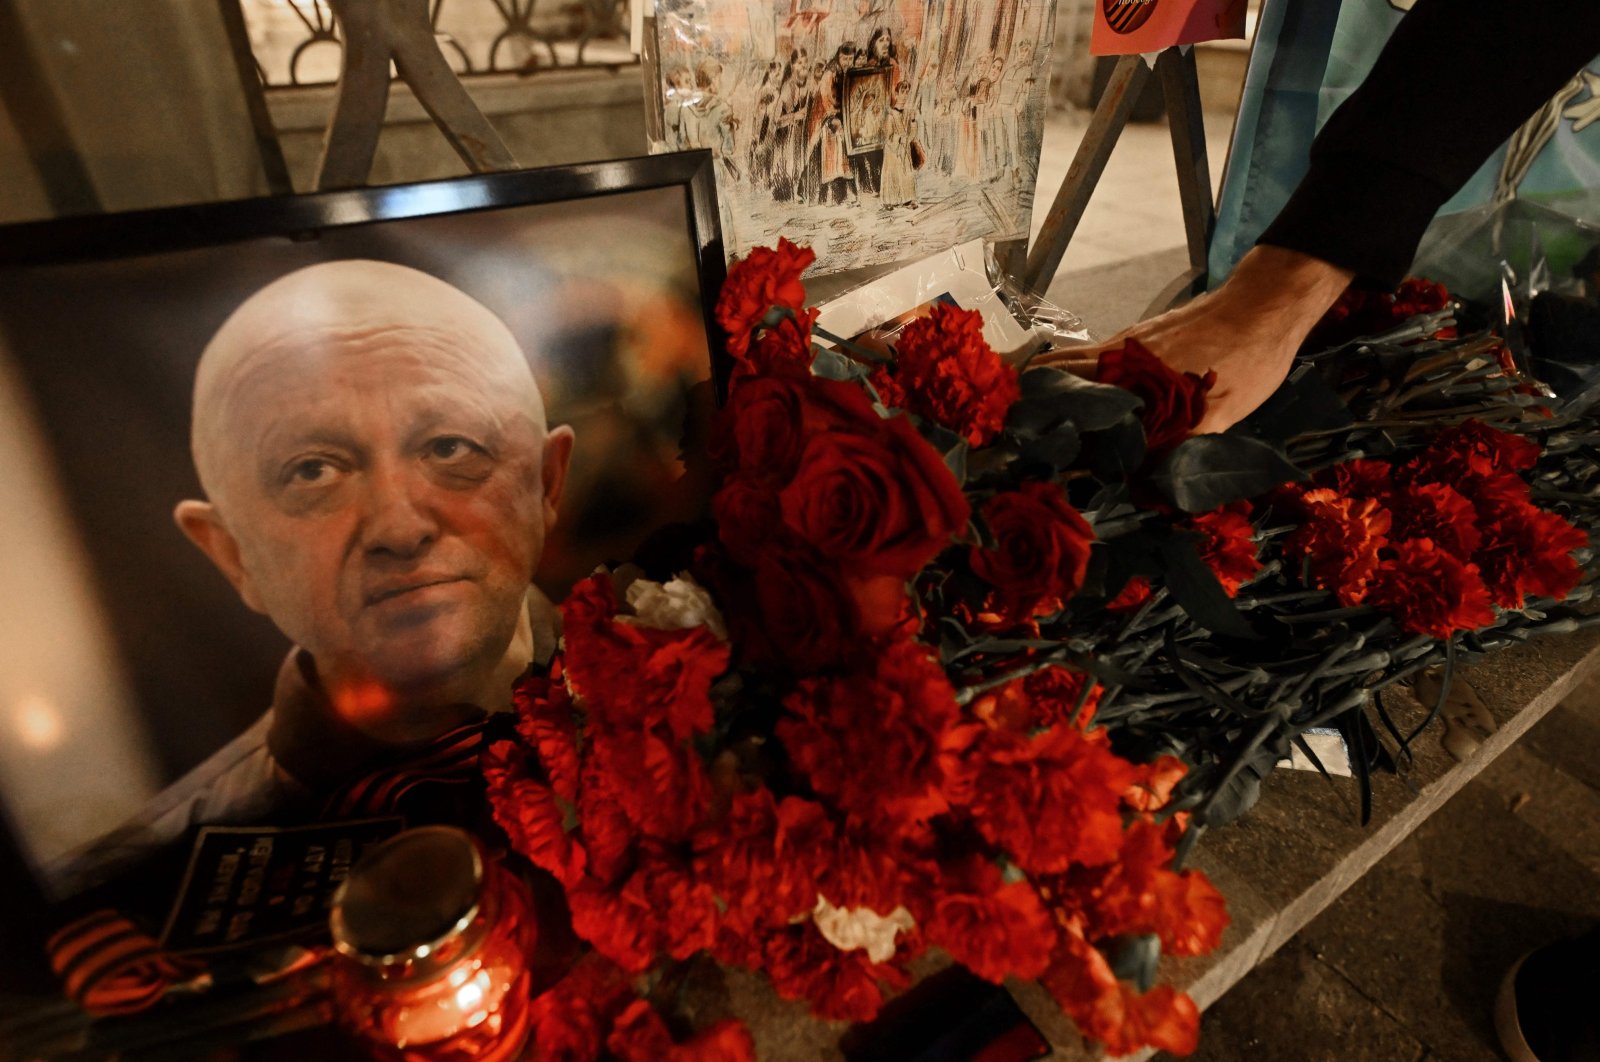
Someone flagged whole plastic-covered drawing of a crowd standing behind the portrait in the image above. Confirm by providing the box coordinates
[650,0,1054,275]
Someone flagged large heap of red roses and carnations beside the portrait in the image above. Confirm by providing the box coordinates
[485,242,1600,1059]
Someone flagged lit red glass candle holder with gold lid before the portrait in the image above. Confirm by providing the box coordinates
[331,827,536,1062]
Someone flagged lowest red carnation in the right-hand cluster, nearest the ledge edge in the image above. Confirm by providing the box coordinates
[1370,539,1494,638]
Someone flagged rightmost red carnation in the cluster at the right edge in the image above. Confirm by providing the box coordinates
[1472,497,1589,608]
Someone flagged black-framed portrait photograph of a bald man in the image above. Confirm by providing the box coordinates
[0,152,725,889]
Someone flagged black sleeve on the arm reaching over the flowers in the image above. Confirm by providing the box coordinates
[1258,0,1600,286]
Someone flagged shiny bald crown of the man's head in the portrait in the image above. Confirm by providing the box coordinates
[190,259,546,499]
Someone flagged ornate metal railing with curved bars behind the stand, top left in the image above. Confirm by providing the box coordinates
[238,0,638,88]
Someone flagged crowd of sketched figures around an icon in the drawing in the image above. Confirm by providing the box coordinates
[664,27,1043,208]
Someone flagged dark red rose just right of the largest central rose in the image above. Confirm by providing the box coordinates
[971,481,1094,622]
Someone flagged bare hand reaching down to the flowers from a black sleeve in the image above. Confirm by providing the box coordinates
[1034,246,1352,433]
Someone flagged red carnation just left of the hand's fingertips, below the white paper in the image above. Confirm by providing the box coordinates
[872,302,1022,446]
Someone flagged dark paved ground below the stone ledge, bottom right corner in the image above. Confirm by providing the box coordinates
[1171,683,1600,1062]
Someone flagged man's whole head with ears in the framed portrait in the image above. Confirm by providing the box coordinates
[176,262,571,707]
